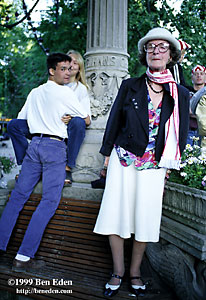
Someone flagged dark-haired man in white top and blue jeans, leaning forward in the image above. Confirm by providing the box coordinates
[0,53,89,272]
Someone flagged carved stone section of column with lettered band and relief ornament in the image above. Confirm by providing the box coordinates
[85,50,128,120]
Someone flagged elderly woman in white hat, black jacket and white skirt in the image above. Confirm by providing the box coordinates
[94,28,189,297]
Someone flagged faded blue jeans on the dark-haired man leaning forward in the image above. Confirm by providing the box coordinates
[0,137,66,258]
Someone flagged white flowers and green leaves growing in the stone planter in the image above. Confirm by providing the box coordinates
[169,137,206,190]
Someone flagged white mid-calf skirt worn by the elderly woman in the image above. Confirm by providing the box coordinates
[94,149,166,242]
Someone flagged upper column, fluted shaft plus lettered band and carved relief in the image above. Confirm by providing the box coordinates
[85,0,128,119]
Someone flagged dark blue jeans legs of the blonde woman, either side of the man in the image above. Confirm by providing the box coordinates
[7,117,86,168]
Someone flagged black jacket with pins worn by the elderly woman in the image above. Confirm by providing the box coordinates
[100,74,189,161]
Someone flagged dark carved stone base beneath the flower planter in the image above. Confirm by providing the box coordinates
[146,240,206,300]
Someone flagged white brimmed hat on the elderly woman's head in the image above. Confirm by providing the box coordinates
[138,27,181,53]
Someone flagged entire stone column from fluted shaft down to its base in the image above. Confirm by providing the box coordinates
[73,0,129,182]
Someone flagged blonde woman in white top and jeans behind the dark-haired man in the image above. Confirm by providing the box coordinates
[7,52,91,186]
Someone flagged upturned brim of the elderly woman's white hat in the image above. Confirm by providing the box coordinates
[138,33,181,53]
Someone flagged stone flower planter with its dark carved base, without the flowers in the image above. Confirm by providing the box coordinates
[147,182,206,300]
